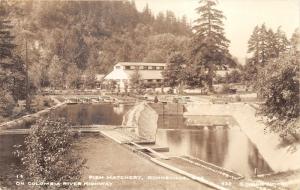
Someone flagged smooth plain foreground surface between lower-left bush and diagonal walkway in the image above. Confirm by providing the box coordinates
[79,136,211,190]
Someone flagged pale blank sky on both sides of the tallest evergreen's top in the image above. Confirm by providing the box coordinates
[135,0,300,63]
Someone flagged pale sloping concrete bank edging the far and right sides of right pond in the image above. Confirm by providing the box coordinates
[184,103,300,171]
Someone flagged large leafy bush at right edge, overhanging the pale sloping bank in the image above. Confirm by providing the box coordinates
[256,53,300,141]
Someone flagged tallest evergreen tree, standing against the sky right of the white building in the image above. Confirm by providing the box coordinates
[190,0,230,91]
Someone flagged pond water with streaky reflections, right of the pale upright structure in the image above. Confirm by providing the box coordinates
[156,116,273,177]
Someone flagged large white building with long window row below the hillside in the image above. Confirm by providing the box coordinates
[104,62,166,89]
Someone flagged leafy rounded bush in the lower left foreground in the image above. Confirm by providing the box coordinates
[14,117,85,186]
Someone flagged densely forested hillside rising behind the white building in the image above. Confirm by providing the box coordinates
[7,1,191,88]
